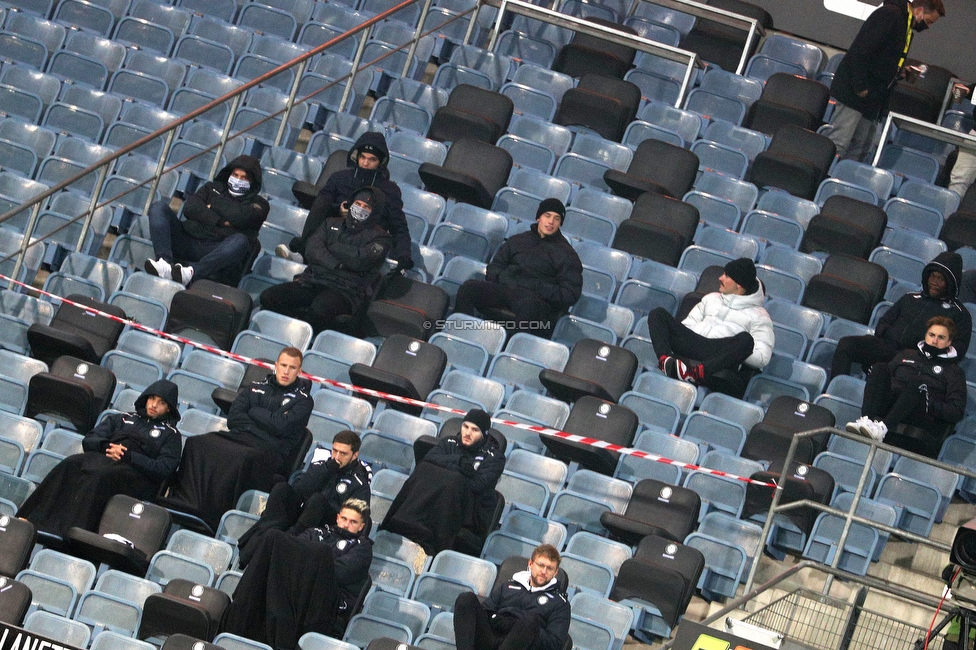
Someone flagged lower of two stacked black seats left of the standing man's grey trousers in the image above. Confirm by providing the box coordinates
[747,125,837,199]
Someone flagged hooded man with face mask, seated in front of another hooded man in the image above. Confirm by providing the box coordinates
[261,187,392,332]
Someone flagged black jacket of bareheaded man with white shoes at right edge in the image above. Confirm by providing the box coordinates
[888,343,966,424]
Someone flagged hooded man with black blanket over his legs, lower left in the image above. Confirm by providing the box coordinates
[17,379,181,537]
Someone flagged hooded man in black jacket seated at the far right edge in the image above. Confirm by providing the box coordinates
[830,252,973,377]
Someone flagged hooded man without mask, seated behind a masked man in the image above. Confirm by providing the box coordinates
[275,131,414,271]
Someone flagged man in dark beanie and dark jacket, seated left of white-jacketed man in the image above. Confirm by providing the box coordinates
[454,199,583,338]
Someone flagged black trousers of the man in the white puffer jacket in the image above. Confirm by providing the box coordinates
[647,307,755,377]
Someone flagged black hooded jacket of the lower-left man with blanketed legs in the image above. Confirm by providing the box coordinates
[81,379,183,480]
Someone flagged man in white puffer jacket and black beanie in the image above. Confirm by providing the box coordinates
[647,257,774,385]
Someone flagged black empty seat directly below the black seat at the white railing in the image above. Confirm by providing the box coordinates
[553,74,641,142]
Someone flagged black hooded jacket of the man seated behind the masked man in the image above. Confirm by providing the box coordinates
[306,131,413,268]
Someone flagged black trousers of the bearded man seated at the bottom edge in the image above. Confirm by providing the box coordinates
[454,591,543,650]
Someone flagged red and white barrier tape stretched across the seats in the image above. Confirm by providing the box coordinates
[0,274,776,488]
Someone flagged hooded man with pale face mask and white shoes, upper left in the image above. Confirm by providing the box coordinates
[144,156,271,286]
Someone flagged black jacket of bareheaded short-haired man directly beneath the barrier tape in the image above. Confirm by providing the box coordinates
[227,373,313,459]
